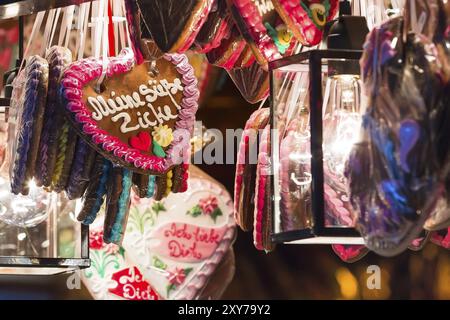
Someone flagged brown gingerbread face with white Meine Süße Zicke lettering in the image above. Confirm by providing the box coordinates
[83,59,183,155]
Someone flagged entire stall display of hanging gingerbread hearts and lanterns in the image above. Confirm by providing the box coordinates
[0,0,450,300]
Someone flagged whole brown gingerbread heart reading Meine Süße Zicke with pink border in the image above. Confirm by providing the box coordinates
[61,49,199,174]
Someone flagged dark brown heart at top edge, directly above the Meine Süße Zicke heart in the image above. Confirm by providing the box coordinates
[134,0,213,53]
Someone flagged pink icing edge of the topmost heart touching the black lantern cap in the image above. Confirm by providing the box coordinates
[275,0,339,46]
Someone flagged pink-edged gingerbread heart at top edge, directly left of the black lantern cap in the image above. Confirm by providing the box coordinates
[272,0,339,46]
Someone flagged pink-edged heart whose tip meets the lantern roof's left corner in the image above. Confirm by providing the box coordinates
[228,0,295,69]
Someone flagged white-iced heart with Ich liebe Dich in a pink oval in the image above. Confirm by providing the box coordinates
[123,167,235,300]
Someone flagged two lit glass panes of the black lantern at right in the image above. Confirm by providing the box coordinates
[272,55,362,235]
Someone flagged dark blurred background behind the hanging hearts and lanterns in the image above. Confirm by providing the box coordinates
[0,15,450,299]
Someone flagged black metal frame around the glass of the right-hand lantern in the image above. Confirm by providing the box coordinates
[269,49,364,245]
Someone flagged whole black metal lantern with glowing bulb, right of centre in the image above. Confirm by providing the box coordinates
[269,1,369,245]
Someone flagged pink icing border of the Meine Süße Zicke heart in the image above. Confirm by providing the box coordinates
[61,48,200,173]
